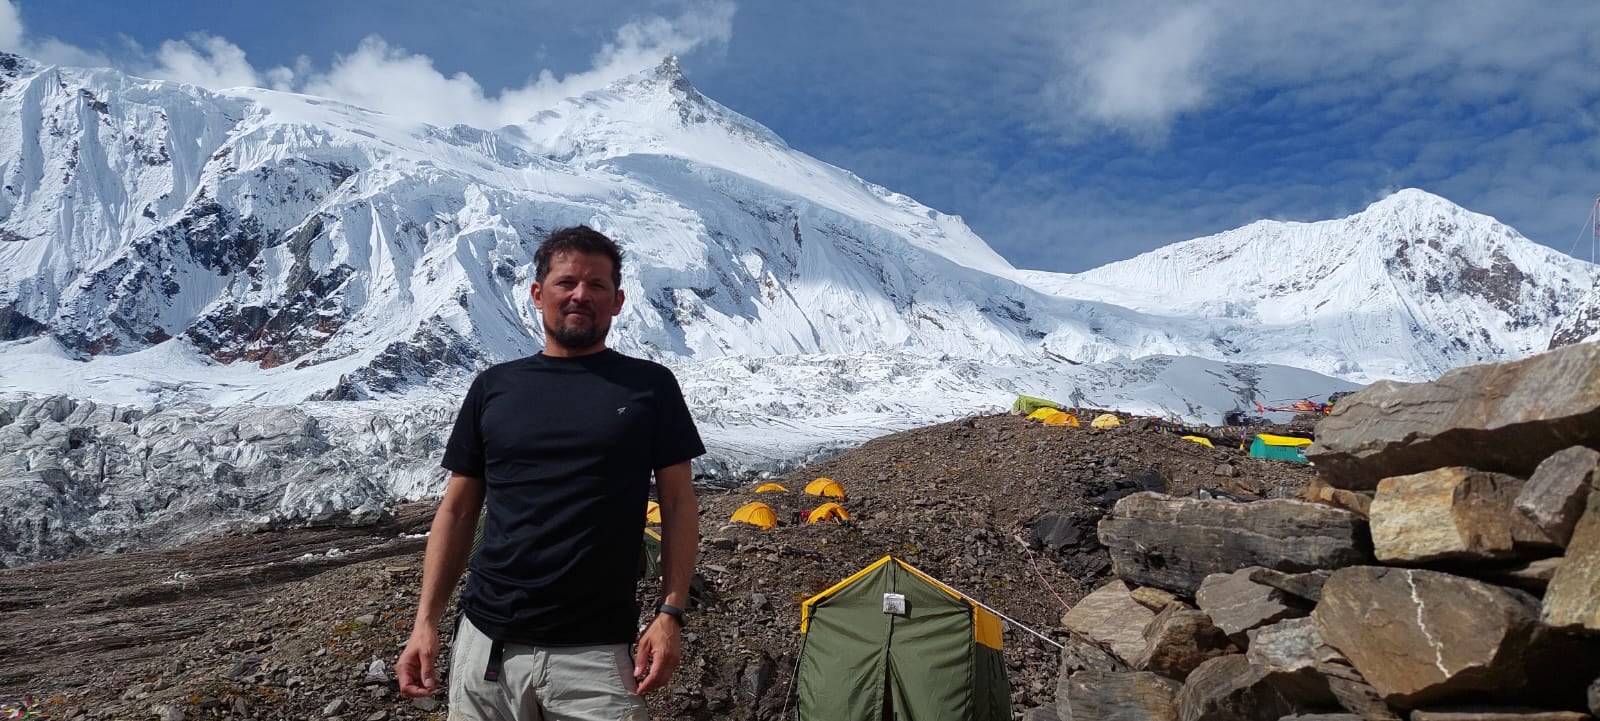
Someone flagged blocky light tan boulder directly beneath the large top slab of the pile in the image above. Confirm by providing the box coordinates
[1371,467,1552,564]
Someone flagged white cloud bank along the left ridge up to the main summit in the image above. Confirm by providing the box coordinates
[0,0,734,128]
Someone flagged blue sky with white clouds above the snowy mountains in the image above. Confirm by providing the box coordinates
[0,0,1600,272]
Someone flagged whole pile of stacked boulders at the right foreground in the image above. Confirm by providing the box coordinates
[1024,344,1600,721]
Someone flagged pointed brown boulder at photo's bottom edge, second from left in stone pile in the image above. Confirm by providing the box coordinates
[1178,654,1309,721]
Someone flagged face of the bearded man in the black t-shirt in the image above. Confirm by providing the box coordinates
[533,251,622,355]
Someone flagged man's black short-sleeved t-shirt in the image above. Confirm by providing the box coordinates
[442,350,706,646]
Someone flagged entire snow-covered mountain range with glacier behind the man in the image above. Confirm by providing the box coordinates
[0,56,1600,561]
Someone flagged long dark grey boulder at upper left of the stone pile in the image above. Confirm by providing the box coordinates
[1099,492,1371,598]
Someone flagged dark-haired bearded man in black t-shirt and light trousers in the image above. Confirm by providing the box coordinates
[395,225,706,721]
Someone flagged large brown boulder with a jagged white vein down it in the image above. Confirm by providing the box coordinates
[1312,566,1539,708]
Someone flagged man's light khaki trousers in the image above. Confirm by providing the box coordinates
[450,617,648,721]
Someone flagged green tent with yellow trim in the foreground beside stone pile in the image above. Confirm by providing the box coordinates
[795,556,1011,721]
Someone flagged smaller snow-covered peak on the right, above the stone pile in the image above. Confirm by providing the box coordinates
[1032,189,1600,382]
